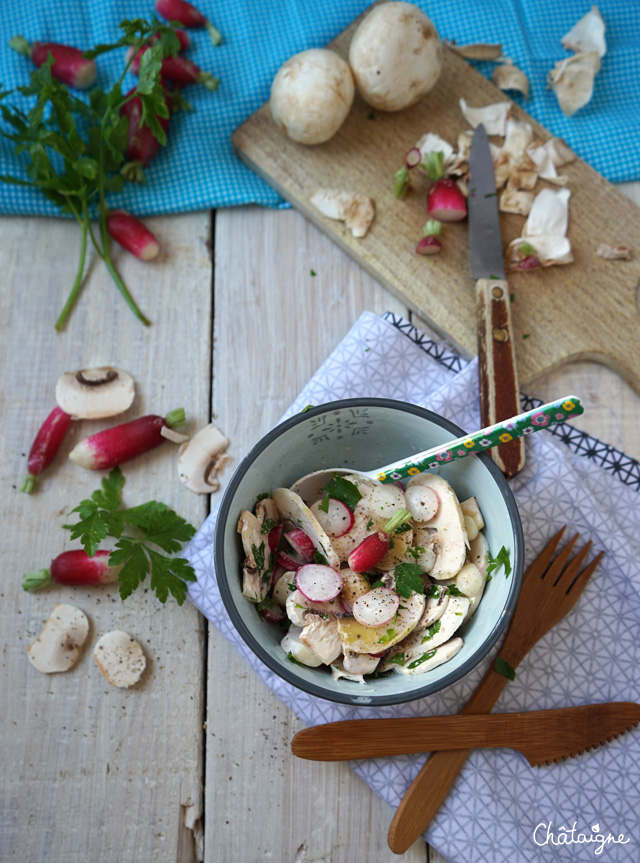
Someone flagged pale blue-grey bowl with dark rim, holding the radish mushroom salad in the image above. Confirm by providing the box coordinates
[214,399,524,706]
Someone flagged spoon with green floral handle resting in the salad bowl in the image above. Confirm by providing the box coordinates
[291,396,584,501]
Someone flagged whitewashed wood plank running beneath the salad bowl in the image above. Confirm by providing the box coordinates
[205,208,426,863]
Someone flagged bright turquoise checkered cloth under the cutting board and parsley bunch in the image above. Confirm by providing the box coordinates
[0,0,640,215]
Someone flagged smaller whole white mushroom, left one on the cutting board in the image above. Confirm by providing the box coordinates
[270,48,355,144]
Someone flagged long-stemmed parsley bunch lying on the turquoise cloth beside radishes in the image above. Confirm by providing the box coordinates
[0,16,180,330]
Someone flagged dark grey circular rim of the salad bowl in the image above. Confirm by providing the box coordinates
[213,397,524,707]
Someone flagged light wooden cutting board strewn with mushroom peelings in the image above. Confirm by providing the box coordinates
[233,5,640,392]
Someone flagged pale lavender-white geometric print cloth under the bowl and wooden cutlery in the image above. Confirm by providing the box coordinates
[186,312,640,863]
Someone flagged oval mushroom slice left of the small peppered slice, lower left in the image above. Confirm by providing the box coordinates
[27,602,89,674]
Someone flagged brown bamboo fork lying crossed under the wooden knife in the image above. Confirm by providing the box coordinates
[387,525,604,854]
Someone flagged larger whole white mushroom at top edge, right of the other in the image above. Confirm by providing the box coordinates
[349,2,442,111]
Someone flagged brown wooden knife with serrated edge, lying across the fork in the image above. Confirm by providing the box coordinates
[291,701,640,767]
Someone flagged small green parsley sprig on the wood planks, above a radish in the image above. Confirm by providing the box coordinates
[63,467,196,605]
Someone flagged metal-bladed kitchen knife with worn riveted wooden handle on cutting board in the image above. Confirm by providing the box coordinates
[467,123,525,479]
